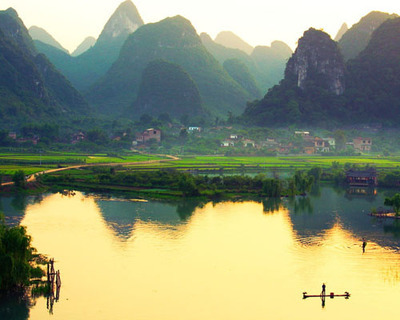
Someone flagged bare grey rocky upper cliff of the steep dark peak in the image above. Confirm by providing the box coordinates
[285,28,345,95]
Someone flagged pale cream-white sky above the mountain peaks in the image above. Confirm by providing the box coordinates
[0,0,400,51]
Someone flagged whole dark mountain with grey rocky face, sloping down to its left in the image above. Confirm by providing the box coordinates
[243,28,345,126]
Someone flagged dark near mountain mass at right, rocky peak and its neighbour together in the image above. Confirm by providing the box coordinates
[242,12,400,128]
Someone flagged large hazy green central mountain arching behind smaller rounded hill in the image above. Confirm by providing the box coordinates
[88,16,250,116]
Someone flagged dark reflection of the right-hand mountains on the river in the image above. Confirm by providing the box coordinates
[285,187,400,249]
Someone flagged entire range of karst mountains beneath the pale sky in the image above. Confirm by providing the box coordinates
[0,0,400,127]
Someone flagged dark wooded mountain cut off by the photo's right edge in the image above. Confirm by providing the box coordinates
[346,18,400,126]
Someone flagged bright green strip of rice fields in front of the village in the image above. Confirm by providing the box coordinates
[0,153,400,175]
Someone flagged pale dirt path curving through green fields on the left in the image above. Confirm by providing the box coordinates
[1,154,180,186]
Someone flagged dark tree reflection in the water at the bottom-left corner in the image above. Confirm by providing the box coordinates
[0,296,31,320]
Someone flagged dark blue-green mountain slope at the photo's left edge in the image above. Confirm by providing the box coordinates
[0,9,89,128]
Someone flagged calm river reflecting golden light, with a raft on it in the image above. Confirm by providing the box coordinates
[0,187,400,320]
